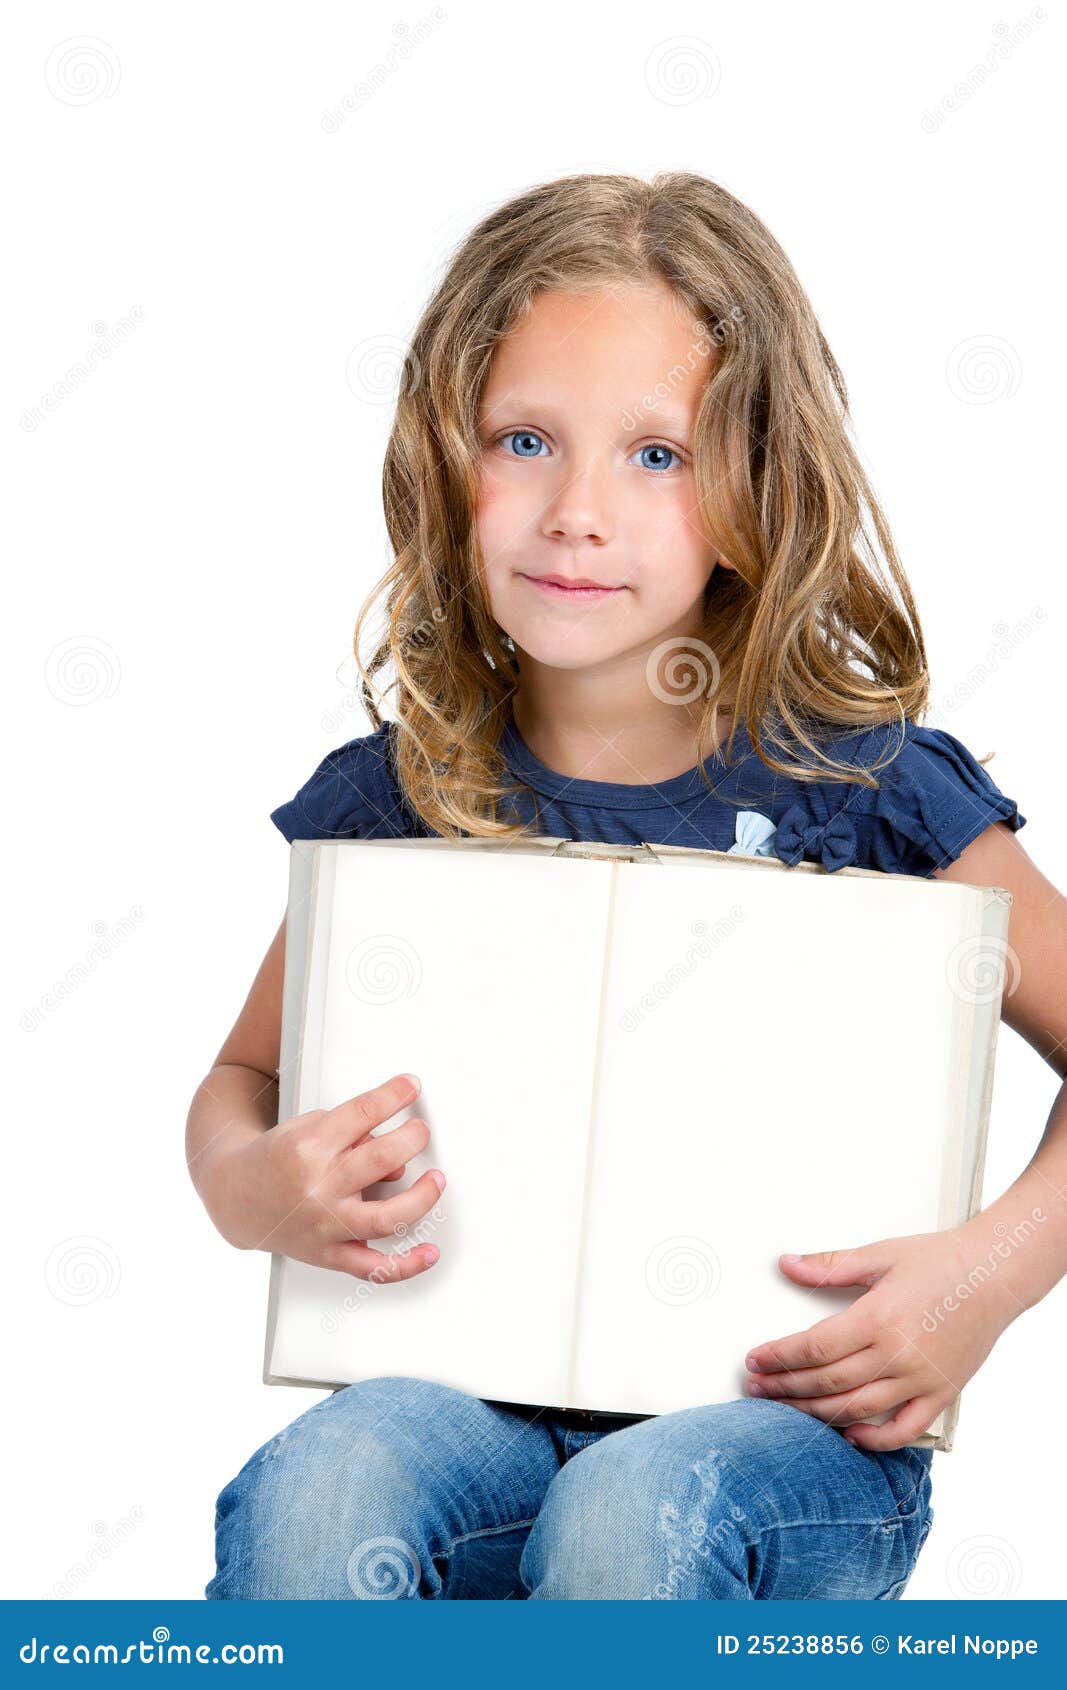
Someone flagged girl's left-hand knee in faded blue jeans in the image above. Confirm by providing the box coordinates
[205,1377,446,1600]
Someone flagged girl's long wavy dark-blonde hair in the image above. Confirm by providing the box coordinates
[353,171,930,838]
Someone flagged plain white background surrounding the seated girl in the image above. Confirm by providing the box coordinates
[0,0,1067,1599]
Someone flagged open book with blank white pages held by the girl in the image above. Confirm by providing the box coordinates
[264,835,1011,1450]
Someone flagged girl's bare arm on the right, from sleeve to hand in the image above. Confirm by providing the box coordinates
[746,821,1067,1450]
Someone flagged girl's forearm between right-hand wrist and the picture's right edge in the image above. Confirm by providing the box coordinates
[962,1080,1067,1317]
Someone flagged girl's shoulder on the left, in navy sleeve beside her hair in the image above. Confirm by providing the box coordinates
[271,722,414,842]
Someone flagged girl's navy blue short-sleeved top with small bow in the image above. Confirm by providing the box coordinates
[271,718,1026,875]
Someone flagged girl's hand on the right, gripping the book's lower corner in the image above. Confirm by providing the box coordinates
[746,1225,1021,1450]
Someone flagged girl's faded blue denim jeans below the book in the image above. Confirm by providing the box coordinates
[205,1376,933,1602]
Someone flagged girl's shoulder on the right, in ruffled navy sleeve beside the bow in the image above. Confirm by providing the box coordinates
[774,722,1026,875]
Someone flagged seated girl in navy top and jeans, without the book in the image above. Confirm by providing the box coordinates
[188,172,1067,1600]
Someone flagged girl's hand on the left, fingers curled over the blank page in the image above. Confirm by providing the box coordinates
[216,1073,445,1283]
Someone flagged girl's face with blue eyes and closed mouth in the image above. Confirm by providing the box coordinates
[477,286,717,669]
